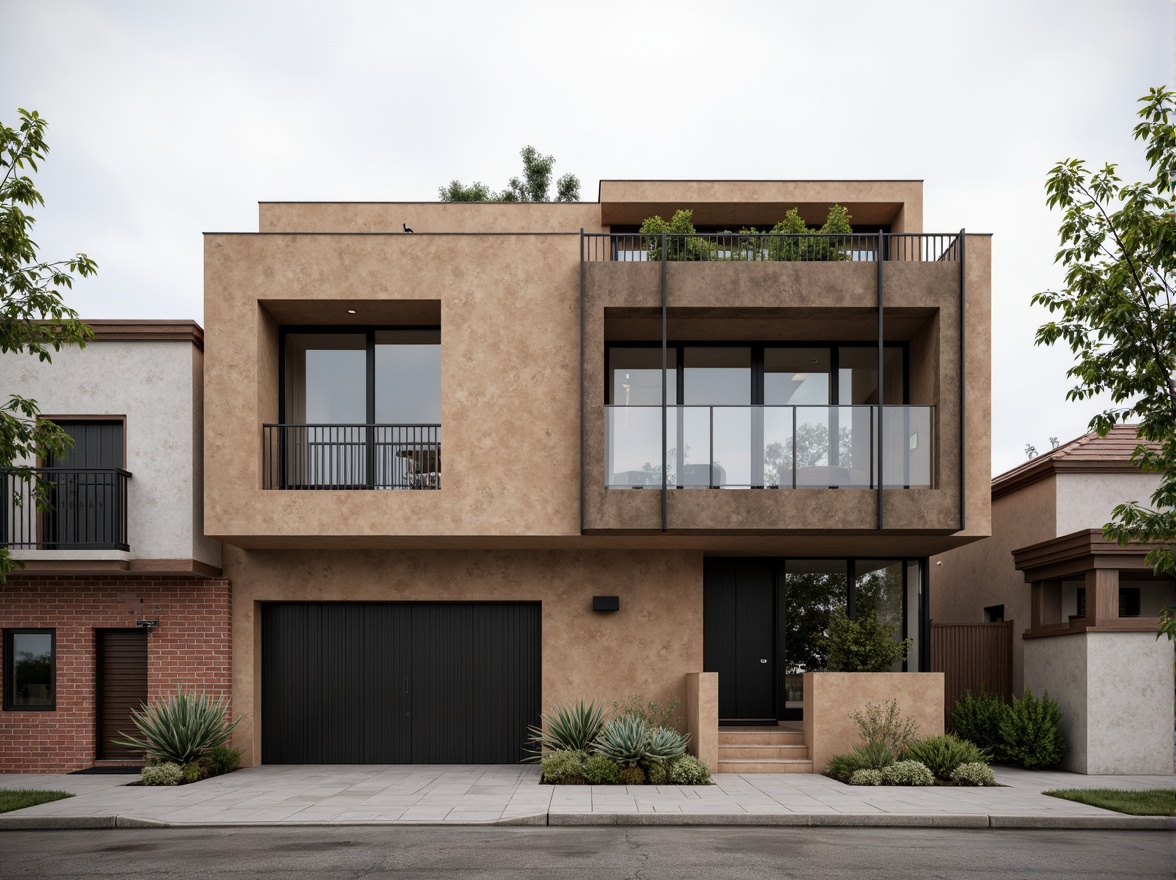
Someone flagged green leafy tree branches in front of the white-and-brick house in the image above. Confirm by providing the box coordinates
[0,109,98,584]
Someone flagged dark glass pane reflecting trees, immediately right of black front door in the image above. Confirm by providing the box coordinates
[784,559,849,708]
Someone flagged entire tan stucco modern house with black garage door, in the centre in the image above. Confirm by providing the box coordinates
[205,181,990,764]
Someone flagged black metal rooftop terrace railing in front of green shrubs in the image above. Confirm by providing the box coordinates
[583,232,960,262]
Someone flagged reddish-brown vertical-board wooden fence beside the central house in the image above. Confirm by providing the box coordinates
[931,620,1013,721]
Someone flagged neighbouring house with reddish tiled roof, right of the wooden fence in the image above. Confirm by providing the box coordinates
[931,425,1176,773]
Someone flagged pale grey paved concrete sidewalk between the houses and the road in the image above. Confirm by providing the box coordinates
[0,765,1176,831]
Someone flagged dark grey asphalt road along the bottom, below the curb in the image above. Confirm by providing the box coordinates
[0,827,1174,880]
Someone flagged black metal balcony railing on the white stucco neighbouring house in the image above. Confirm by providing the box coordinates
[0,467,131,551]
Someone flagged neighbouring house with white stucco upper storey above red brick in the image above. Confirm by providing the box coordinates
[0,320,224,772]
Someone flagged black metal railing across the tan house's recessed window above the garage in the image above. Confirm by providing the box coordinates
[262,425,441,489]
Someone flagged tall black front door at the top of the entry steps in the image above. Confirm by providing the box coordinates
[702,559,782,722]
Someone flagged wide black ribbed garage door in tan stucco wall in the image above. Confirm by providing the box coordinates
[261,602,540,764]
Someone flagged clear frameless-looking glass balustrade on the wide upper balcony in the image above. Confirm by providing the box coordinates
[604,406,935,489]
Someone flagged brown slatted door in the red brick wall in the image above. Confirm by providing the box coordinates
[95,629,147,761]
